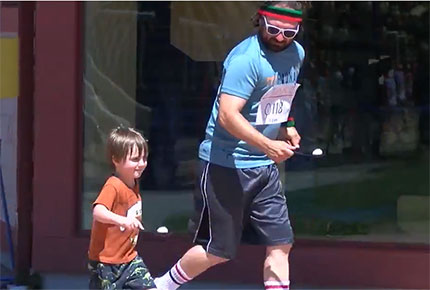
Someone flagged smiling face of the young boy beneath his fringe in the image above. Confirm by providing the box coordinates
[112,145,147,179]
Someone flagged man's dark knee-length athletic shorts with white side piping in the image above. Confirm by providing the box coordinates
[190,161,293,259]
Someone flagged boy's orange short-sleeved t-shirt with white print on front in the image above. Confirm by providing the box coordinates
[88,176,142,264]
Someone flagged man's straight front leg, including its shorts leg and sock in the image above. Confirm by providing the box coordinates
[243,165,294,290]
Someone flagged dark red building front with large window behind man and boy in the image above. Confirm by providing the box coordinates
[0,1,430,289]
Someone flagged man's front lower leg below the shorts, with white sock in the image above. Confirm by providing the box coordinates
[263,244,291,290]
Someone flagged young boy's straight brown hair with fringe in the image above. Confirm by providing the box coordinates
[106,127,149,167]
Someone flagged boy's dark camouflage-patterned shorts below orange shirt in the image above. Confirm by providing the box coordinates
[88,256,156,290]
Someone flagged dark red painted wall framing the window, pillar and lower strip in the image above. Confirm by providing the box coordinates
[33,2,430,289]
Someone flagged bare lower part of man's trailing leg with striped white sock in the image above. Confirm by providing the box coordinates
[154,245,228,290]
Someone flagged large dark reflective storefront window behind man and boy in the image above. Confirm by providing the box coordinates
[82,1,429,243]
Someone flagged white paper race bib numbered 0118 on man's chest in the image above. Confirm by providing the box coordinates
[255,84,300,125]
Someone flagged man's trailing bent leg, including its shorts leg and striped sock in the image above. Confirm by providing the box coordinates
[154,162,243,290]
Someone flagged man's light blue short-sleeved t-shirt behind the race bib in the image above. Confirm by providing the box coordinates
[199,35,305,168]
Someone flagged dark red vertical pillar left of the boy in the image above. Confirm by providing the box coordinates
[33,2,82,270]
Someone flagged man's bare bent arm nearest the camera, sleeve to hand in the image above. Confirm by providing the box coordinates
[218,93,295,163]
